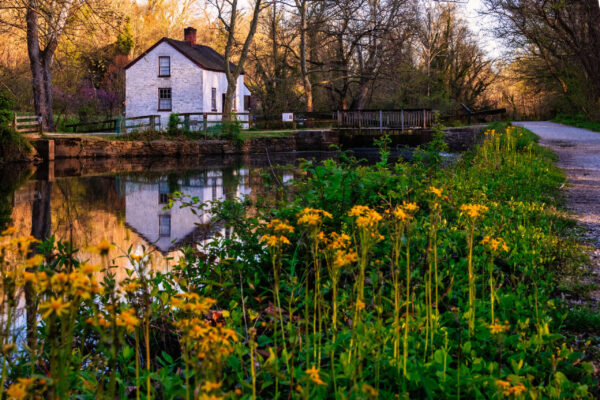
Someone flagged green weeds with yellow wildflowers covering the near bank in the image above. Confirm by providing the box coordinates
[0,125,596,399]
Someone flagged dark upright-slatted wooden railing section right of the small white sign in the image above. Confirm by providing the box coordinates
[335,109,434,133]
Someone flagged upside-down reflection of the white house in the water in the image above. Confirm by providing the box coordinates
[125,169,251,253]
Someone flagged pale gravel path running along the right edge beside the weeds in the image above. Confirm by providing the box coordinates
[514,122,600,301]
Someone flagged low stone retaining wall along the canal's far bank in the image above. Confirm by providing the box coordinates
[22,126,482,161]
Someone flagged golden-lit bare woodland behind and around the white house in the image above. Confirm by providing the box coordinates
[0,0,500,122]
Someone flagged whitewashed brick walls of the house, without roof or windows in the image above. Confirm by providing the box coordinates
[125,42,250,129]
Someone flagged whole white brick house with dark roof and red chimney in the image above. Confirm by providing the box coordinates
[125,28,250,129]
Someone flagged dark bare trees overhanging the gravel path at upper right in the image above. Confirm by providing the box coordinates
[484,0,600,118]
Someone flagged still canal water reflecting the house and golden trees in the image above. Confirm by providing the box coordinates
[0,151,404,279]
